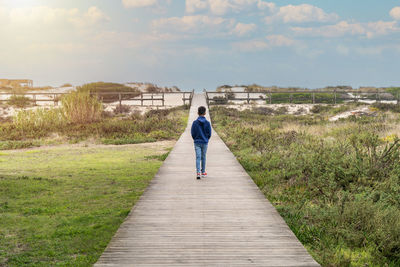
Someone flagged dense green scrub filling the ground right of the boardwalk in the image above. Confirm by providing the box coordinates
[211,107,400,266]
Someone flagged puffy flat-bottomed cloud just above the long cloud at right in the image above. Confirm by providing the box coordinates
[265,4,339,23]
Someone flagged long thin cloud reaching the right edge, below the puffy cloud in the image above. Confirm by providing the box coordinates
[291,21,400,38]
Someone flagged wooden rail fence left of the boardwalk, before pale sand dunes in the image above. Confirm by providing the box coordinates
[0,90,194,106]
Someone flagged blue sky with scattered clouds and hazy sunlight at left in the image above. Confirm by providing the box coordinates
[0,0,400,90]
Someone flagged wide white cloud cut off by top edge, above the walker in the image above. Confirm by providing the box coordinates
[186,0,275,15]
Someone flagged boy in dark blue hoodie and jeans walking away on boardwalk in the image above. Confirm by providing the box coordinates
[191,106,211,180]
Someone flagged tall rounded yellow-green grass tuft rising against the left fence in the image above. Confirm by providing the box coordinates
[61,91,103,123]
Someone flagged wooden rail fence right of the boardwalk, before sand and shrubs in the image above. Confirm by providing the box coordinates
[204,91,400,105]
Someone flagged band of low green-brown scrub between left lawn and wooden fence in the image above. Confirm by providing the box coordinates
[0,107,188,149]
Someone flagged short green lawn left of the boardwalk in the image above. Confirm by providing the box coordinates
[0,142,172,266]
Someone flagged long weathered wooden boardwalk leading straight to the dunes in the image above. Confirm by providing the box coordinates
[95,94,319,267]
